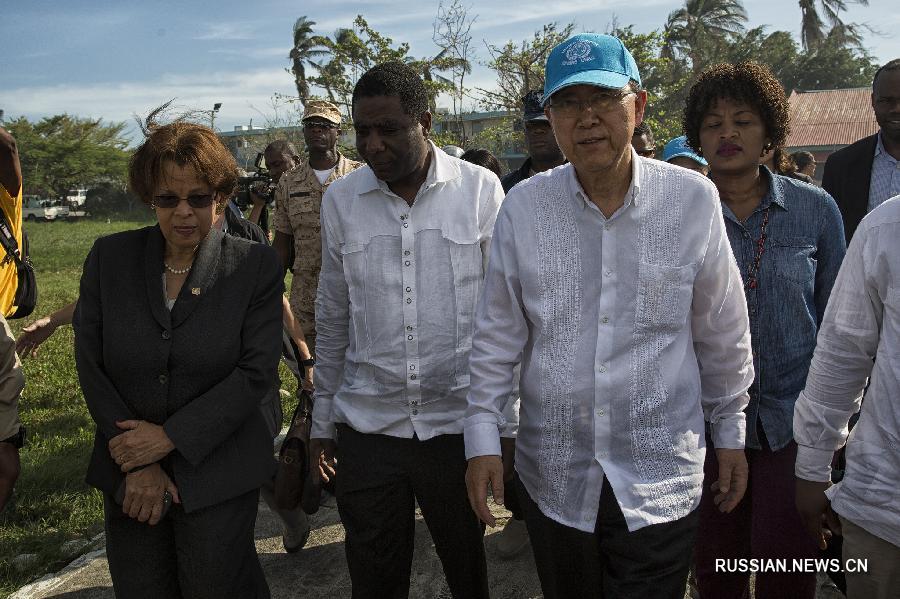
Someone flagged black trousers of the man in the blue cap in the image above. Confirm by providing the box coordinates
[515,476,697,599]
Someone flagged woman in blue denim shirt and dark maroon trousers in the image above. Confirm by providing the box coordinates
[683,62,846,599]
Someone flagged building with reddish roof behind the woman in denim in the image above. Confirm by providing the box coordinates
[785,87,878,179]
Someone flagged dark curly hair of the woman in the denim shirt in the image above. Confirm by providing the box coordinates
[681,61,791,153]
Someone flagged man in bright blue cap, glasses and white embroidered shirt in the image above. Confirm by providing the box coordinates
[465,34,753,599]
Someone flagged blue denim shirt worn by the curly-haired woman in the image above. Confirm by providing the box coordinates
[722,166,846,451]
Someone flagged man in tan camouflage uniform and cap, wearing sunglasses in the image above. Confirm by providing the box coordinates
[266,100,361,358]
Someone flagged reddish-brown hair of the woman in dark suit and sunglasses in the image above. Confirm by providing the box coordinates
[128,121,238,208]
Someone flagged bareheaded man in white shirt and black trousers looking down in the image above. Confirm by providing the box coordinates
[310,63,505,599]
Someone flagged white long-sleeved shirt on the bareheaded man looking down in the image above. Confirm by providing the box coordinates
[312,144,503,440]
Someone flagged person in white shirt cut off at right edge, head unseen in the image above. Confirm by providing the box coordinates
[794,196,900,599]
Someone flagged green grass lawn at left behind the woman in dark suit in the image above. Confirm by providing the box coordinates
[0,215,296,599]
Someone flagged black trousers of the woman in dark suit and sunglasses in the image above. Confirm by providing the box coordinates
[103,490,269,599]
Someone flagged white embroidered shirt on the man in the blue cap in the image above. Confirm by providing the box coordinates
[465,152,753,532]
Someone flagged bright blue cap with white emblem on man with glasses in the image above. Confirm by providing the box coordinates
[543,33,641,105]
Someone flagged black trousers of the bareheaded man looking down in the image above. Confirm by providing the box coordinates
[337,424,488,599]
